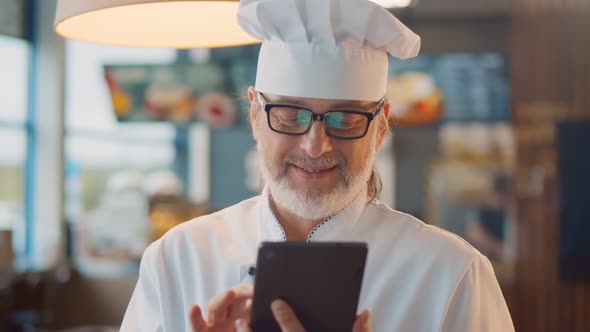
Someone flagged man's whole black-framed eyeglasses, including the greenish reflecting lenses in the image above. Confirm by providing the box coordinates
[256,92,385,139]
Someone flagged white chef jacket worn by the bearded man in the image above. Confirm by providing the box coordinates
[121,191,514,332]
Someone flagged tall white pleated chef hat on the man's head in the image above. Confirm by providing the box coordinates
[238,0,420,101]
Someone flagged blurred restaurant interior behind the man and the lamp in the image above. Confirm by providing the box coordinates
[0,0,590,332]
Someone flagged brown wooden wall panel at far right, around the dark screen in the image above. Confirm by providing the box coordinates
[507,0,590,332]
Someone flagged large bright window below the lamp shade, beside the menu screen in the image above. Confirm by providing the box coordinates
[65,41,176,275]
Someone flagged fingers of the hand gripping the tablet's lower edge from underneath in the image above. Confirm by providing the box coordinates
[236,300,371,332]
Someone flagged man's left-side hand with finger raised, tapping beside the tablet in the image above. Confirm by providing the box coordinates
[189,285,253,332]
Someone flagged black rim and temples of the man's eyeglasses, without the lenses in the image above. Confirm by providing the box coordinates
[256,92,385,140]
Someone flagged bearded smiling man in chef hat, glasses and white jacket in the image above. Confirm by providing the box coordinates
[121,0,514,332]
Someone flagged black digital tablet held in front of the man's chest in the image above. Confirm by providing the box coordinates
[250,242,367,332]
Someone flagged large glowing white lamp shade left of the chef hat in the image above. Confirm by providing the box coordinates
[55,0,258,48]
